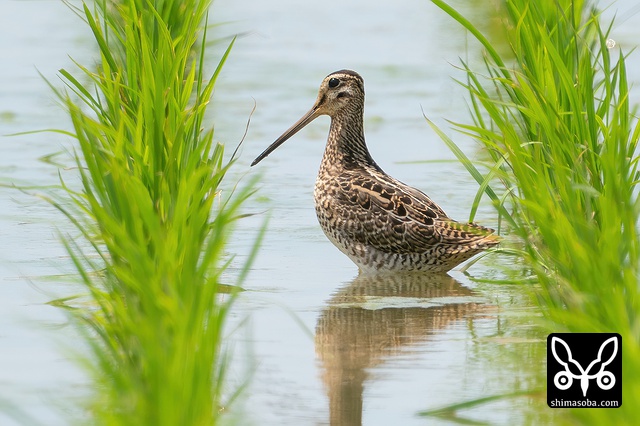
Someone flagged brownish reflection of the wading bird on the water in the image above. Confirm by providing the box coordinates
[315,274,482,426]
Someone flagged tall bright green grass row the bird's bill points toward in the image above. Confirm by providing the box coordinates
[45,0,252,425]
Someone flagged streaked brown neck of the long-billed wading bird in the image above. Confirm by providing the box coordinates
[322,108,377,168]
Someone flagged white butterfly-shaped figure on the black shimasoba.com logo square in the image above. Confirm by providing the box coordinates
[551,336,618,397]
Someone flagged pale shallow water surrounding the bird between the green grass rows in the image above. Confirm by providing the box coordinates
[0,0,638,425]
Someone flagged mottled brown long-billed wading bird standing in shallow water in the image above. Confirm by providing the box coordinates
[251,70,499,273]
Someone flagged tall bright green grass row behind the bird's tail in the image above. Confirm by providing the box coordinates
[433,0,640,424]
